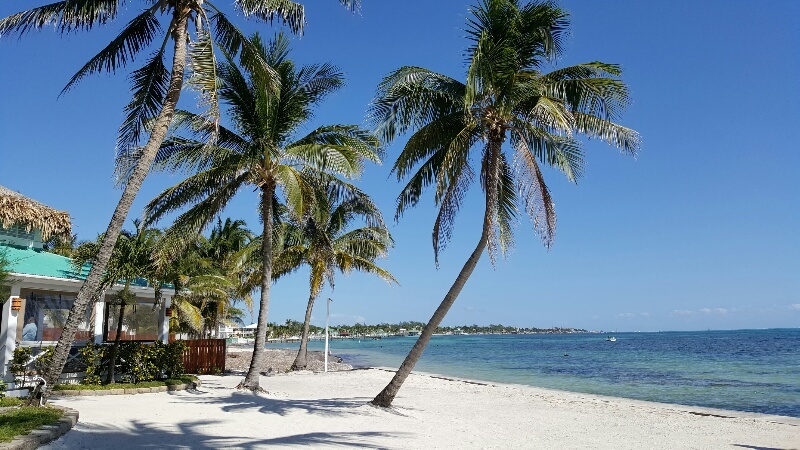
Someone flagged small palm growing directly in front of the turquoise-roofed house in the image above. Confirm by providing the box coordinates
[72,220,161,384]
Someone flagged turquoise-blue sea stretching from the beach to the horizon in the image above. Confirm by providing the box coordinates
[270,329,800,417]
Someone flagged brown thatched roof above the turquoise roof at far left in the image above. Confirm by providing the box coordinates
[0,186,72,239]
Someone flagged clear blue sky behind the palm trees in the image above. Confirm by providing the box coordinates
[0,0,800,331]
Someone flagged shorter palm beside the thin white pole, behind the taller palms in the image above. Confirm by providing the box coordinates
[281,185,397,370]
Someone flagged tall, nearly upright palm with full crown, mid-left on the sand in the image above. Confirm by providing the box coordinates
[145,35,379,391]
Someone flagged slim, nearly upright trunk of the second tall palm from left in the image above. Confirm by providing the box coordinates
[236,181,275,392]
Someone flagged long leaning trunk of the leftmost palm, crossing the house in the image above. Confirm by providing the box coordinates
[43,9,189,401]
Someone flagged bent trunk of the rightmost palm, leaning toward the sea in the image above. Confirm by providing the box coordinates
[370,140,502,408]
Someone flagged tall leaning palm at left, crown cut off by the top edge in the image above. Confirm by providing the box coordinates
[0,0,359,392]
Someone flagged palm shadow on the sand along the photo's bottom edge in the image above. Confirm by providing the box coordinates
[61,420,407,450]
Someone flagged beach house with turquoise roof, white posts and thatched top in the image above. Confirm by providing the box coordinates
[0,186,174,381]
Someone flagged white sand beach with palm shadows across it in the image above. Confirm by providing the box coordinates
[45,369,800,450]
